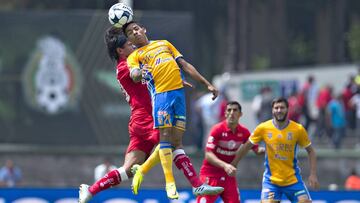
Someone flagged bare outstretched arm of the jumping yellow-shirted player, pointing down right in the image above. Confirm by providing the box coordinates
[177,58,219,100]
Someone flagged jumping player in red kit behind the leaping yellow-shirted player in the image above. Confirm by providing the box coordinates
[79,27,222,203]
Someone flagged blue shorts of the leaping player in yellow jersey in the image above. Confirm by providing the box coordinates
[153,88,186,130]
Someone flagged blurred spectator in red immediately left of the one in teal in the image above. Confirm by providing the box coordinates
[315,85,332,137]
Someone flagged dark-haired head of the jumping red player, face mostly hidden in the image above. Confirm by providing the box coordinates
[105,27,134,61]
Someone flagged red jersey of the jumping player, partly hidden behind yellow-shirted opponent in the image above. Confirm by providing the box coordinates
[116,60,153,126]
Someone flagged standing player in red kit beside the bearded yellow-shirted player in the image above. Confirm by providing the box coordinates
[196,101,264,203]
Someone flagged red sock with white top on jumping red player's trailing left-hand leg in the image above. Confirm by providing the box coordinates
[89,167,128,196]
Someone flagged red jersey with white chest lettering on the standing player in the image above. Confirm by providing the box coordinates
[200,120,258,177]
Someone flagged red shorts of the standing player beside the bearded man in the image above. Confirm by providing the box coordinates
[196,175,240,203]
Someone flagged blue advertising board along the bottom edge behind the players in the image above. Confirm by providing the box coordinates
[0,188,360,203]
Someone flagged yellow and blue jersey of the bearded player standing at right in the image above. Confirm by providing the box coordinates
[249,120,311,186]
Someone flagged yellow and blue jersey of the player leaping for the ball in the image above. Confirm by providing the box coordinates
[127,40,183,94]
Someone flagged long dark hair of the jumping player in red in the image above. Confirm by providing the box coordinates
[104,27,127,61]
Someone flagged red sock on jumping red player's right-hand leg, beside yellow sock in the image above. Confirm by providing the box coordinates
[173,149,202,187]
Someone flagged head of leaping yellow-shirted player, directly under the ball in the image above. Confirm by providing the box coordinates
[122,21,149,47]
